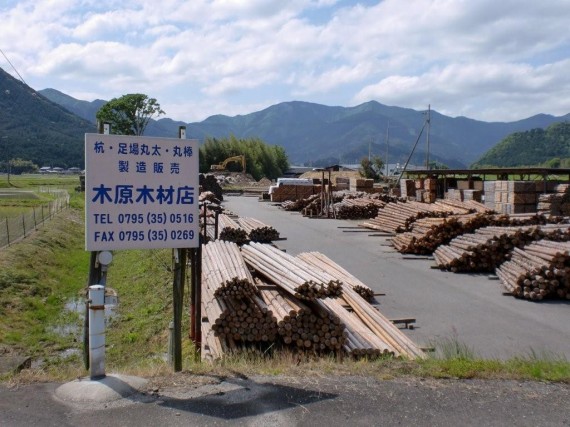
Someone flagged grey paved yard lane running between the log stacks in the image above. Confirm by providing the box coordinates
[224,196,570,359]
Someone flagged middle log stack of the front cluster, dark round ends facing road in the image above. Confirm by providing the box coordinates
[257,281,346,353]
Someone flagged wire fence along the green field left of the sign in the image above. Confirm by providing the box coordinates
[0,189,69,249]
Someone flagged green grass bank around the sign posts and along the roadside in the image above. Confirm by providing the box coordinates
[0,176,570,382]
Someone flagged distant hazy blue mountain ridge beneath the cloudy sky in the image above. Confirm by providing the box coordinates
[40,89,570,167]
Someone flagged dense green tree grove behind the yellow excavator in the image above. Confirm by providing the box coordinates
[200,135,289,180]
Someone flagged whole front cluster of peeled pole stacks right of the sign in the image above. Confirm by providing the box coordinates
[197,241,425,359]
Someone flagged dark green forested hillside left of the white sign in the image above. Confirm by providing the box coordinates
[0,68,96,168]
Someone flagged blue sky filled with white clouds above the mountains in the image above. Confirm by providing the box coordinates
[0,0,570,122]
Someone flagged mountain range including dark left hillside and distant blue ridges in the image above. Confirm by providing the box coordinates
[0,69,570,167]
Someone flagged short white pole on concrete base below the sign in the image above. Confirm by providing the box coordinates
[89,285,105,380]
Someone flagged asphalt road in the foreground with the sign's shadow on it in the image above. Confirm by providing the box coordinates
[0,374,570,427]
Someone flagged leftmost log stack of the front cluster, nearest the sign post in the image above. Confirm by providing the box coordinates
[202,241,277,357]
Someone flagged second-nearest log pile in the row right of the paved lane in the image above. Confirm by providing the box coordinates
[433,225,569,272]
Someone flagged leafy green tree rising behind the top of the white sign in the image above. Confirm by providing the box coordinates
[96,93,165,136]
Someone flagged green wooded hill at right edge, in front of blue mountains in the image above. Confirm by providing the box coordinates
[473,122,570,167]
